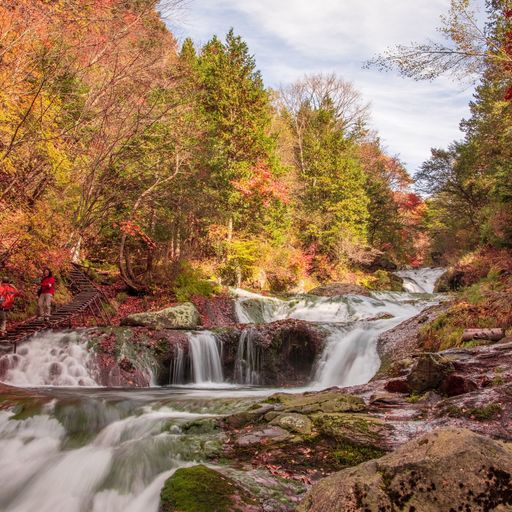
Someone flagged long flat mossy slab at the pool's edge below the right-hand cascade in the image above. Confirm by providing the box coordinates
[268,391,366,414]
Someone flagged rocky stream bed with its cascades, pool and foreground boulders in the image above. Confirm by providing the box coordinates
[0,270,512,512]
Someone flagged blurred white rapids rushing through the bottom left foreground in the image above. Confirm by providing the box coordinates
[0,406,212,512]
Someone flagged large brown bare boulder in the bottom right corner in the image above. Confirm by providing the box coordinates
[298,428,512,512]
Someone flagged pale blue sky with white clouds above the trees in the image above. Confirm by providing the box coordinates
[168,0,480,174]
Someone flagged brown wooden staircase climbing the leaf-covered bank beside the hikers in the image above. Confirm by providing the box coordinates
[0,265,111,355]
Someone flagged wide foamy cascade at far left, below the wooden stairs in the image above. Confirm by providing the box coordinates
[0,332,98,387]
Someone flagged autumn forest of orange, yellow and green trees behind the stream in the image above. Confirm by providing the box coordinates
[0,0,512,292]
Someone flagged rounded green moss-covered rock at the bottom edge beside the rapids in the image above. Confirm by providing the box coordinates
[160,464,262,512]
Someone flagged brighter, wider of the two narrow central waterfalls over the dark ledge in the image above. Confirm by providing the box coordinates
[188,331,224,384]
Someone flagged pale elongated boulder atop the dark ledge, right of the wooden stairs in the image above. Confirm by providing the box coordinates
[121,302,200,329]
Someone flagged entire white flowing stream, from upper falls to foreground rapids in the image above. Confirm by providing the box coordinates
[0,269,441,512]
